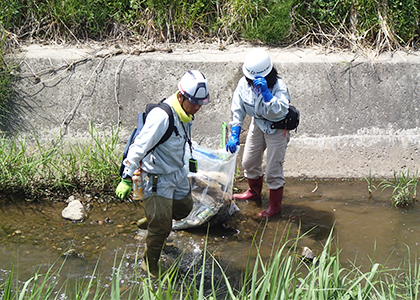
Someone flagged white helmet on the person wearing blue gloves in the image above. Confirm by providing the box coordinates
[242,49,273,80]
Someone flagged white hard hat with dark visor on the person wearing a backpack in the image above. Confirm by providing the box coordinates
[178,70,210,105]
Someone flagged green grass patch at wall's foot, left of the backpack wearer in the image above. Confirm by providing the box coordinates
[0,123,122,199]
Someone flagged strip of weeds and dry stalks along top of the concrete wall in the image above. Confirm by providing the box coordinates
[0,0,420,51]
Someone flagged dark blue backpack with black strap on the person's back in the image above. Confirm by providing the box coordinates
[120,99,178,176]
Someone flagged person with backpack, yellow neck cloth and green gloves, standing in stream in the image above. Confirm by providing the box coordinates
[116,70,209,276]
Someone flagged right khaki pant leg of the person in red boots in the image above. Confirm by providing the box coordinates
[264,129,290,190]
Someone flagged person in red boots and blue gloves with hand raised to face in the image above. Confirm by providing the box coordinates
[226,49,290,218]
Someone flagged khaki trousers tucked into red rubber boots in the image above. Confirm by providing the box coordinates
[242,118,290,190]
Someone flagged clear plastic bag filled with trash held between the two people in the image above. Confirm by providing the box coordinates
[172,144,239,230]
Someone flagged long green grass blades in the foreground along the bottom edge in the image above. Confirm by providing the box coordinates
[0,227,420,300]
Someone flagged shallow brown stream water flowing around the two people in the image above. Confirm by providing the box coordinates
[0,180,420,285]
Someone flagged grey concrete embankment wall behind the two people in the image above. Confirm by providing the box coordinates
[7,45,420,178]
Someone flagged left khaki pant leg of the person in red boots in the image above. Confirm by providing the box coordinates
[242,118,266,179]
